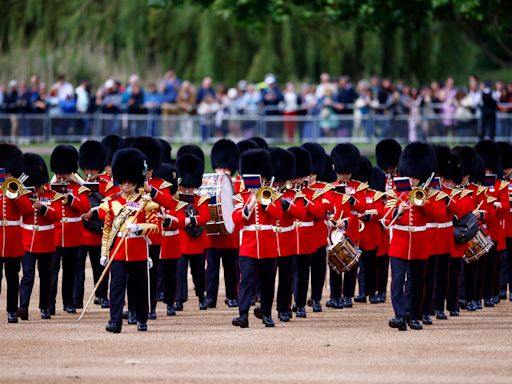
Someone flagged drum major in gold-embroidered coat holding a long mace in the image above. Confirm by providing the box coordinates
[101,148,160,333]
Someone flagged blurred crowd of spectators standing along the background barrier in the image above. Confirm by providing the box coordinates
[0,70,512,142]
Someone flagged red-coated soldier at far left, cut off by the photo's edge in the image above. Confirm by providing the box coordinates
[0,143,32,323]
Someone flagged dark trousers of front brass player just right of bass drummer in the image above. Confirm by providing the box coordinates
[238,256,277,316]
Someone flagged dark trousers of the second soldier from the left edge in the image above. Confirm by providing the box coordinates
[20,252,53,309]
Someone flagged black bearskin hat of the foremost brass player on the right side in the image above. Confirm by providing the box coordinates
[398,141,436,182]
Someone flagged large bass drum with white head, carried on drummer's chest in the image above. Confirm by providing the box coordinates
[199,173,235,235]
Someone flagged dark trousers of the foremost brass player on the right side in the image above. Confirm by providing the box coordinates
[390,257,427,320]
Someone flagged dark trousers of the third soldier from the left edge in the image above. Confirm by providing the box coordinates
[50,247,79,307]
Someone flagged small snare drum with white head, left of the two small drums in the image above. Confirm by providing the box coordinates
[327,230,361,274]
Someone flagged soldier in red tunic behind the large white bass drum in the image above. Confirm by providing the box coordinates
[206,139,240,308]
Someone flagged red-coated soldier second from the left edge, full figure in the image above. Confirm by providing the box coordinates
[18,153,63,320]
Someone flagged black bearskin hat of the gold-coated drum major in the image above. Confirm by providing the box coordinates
[112,148,147,187]
